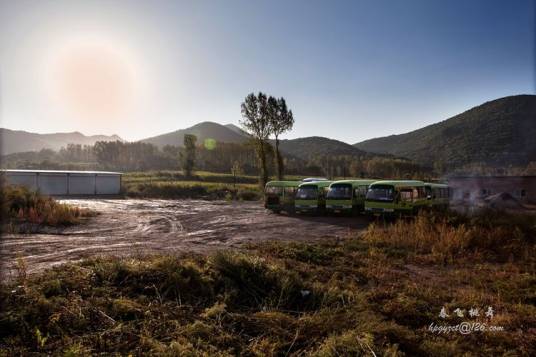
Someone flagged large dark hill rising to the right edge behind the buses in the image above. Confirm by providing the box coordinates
[354,95,536,169]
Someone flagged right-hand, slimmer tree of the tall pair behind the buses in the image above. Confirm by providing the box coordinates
[268,97,294,180]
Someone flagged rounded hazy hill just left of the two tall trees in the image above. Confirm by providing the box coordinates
[140,121,247,147]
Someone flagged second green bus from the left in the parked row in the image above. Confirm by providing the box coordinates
[294,180,331,213]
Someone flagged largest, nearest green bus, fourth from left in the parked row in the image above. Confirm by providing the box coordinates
[365,180,429,216]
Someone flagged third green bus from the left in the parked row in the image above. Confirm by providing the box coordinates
[326,180,376,214]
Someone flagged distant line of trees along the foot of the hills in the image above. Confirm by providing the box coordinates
[2,141,450,178]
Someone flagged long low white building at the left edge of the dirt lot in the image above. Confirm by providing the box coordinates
[1,170,121,196]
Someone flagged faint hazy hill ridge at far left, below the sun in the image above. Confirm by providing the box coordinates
[0,128,122,155]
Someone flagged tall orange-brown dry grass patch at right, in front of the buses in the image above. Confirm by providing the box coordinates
[363,211,536,263]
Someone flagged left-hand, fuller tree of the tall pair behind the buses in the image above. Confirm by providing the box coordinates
[240,92,272,188]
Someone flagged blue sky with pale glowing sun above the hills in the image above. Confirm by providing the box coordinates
[0,0,536,144]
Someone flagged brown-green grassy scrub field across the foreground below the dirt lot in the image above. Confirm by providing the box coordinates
[0,210,536,356]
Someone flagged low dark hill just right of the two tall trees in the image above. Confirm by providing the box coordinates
[279,136,378,160]
